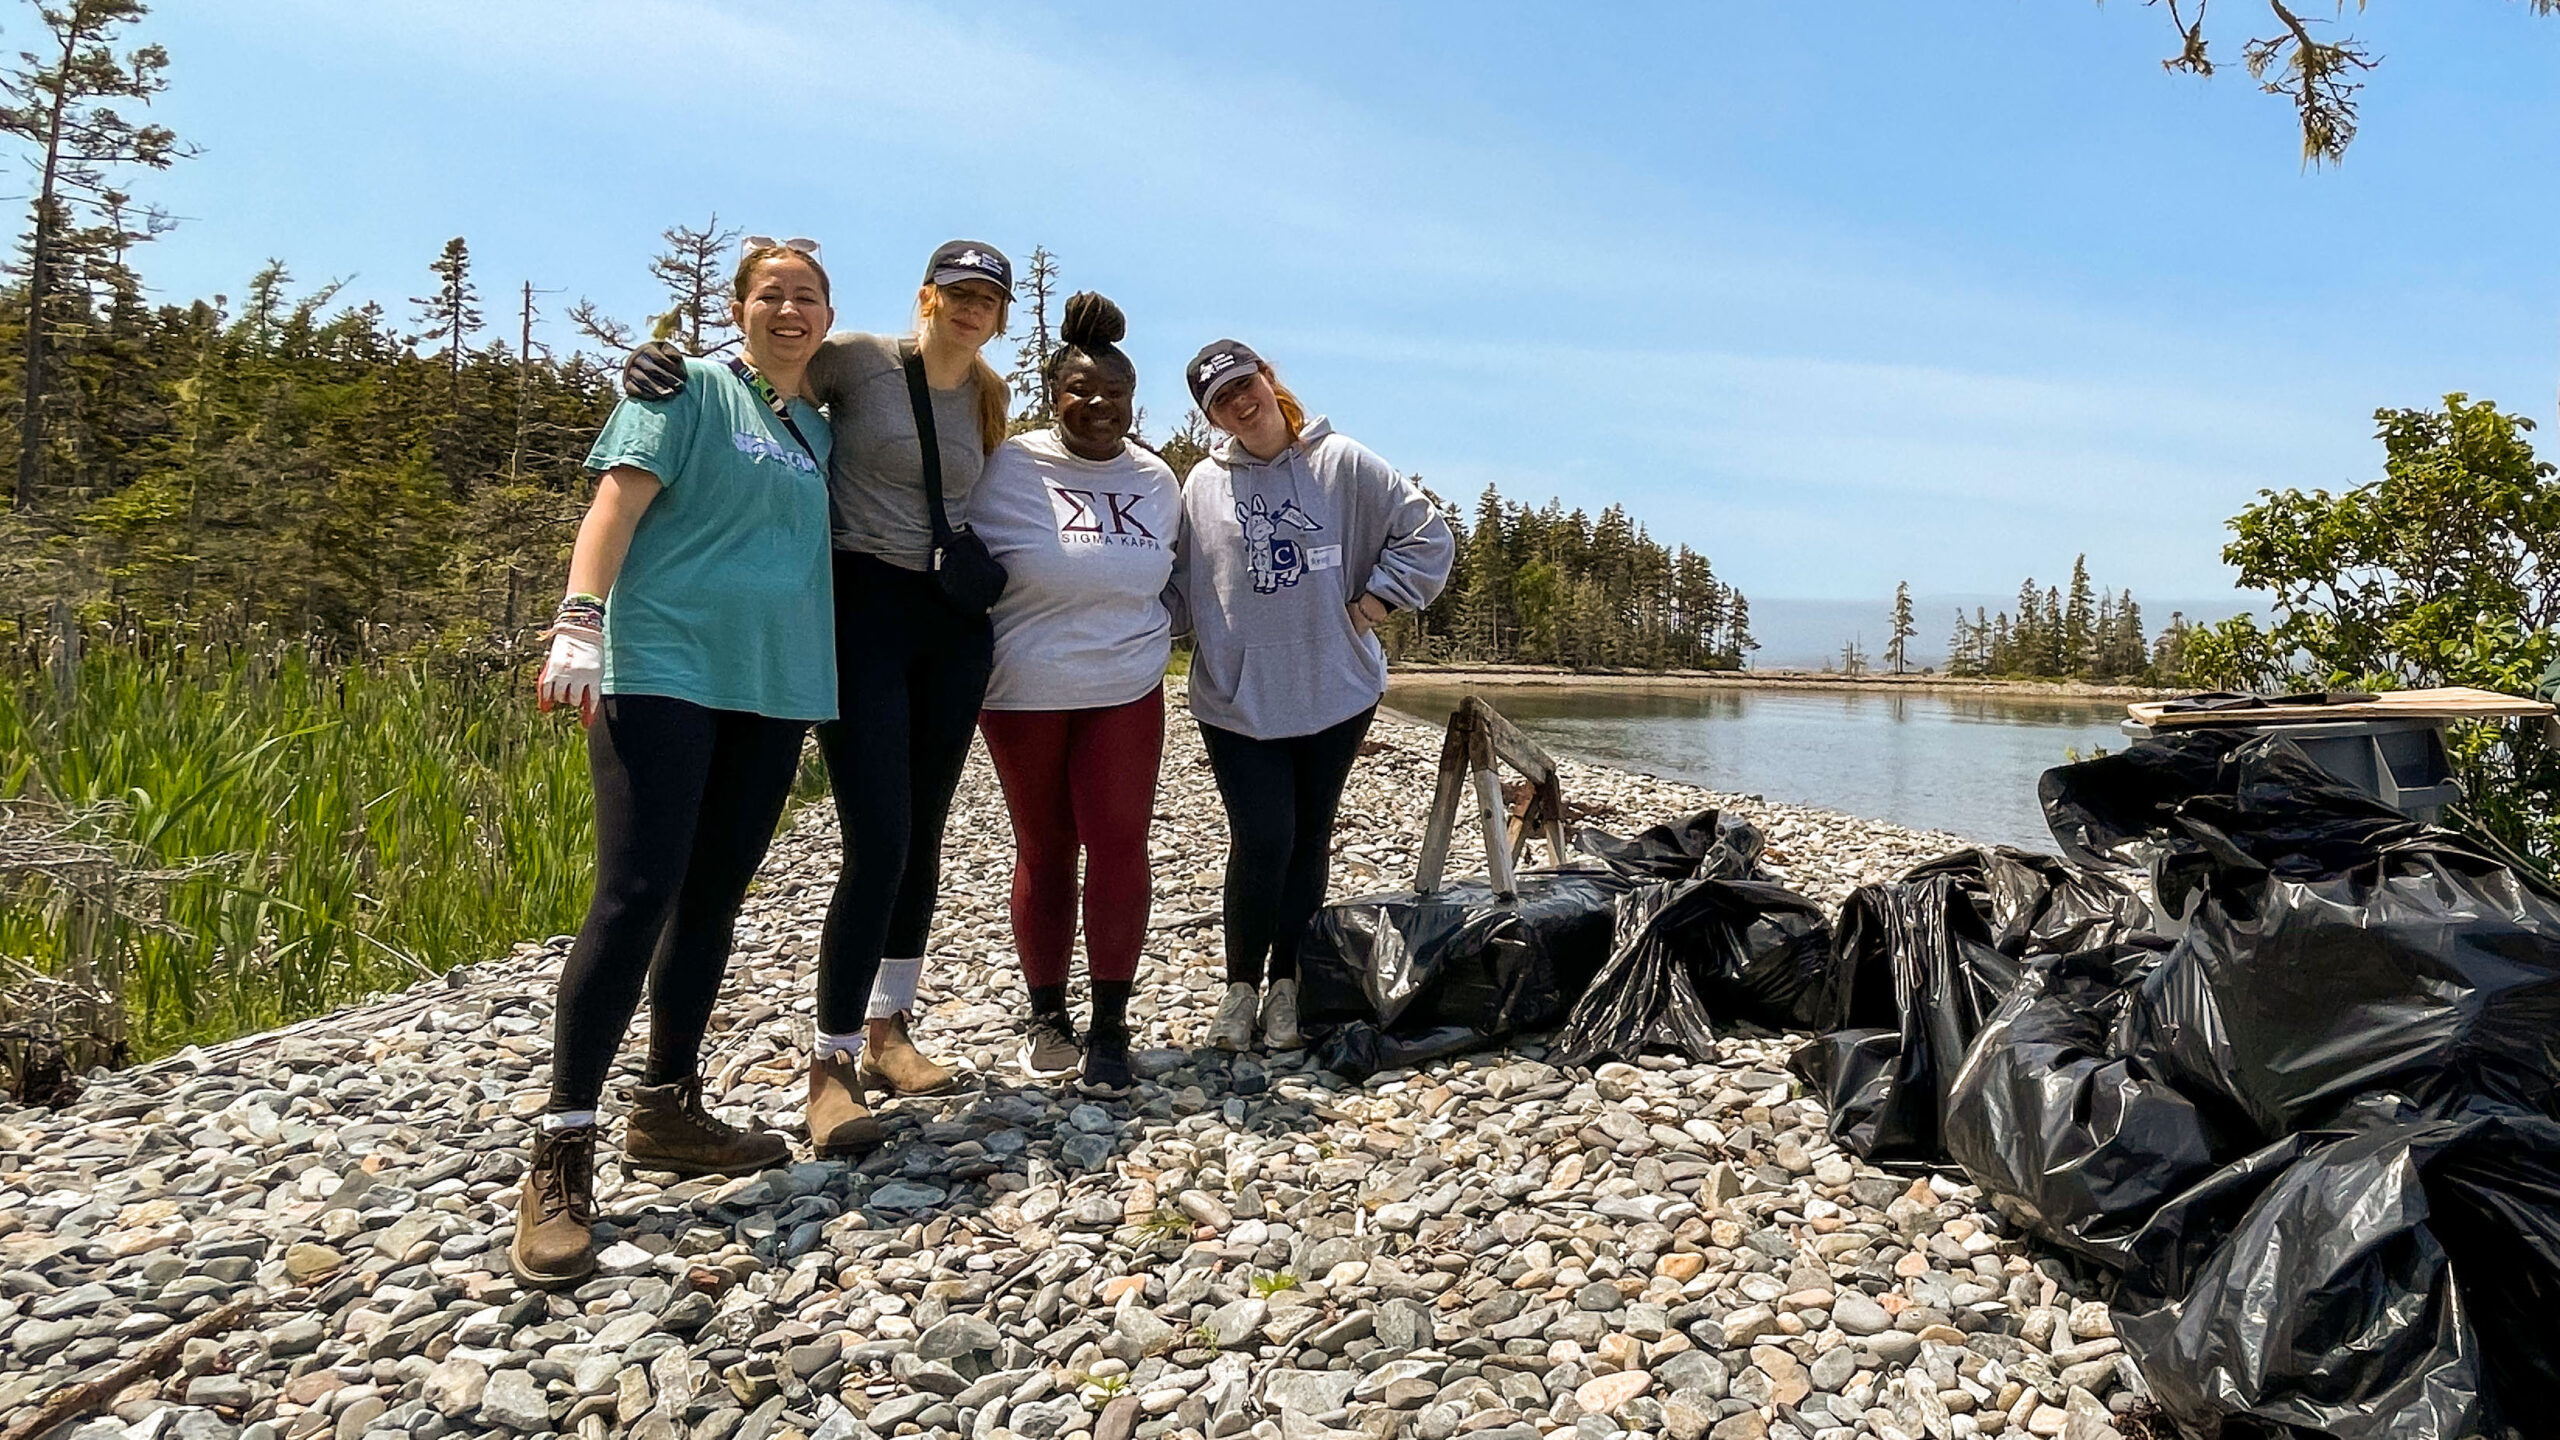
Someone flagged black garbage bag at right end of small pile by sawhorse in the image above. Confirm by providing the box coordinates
[1556,879,1843,1066]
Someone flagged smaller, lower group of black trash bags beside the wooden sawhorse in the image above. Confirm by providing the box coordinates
[1298,810,1843,1079]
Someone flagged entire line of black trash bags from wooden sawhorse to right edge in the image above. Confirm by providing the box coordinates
[1300,730,2560,1440]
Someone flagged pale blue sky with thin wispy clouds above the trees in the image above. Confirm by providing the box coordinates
[120,0,2560,602]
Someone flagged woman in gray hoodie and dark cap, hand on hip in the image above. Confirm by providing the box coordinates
[1175,341,1457,1051]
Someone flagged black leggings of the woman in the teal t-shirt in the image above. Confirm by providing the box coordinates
[550,694,809,1112]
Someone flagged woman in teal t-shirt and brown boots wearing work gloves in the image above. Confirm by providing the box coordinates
[509,241,835,1286]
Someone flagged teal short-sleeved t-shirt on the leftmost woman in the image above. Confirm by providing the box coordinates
[586,359,835,720]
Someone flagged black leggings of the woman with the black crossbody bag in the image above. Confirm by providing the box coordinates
[817,551,996,1035]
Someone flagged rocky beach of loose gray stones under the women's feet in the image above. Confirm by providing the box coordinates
[0,696,2140,1440]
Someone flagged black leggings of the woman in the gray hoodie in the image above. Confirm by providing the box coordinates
[1201,705,1377,984]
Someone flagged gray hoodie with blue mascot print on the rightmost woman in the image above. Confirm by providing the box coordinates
[1172,418,1457,740]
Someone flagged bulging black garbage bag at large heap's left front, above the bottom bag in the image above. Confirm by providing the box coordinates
[1946,945,2240,1266]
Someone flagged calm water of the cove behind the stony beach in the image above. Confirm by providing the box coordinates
[1388,682,2125,851]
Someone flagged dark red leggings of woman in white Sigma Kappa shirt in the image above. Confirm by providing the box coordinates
[978,687,1165,986]
